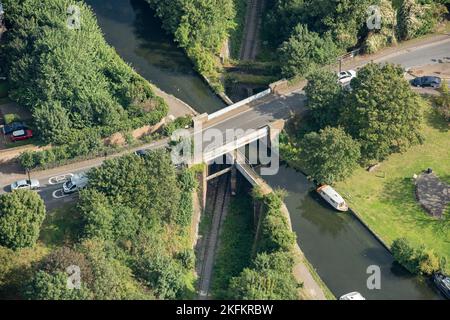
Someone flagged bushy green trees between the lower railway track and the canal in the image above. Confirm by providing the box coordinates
[228,191,301,300]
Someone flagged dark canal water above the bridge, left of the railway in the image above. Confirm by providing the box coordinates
[86,0,225,113]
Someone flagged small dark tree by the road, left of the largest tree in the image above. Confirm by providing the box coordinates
[305,70,342,128]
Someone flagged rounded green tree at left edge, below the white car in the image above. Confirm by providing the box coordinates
[0,190,45,249]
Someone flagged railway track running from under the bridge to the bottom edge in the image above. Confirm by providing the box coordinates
[198,174,230,300]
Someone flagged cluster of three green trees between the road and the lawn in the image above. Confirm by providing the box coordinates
[282,63,426,183]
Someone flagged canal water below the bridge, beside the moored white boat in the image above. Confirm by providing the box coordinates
[263,166,441,300]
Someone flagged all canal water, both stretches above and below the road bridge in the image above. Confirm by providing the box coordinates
[87,0,440,299]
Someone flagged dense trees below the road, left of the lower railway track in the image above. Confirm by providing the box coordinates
[0,150,197,300]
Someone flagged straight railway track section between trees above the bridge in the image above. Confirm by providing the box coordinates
[239,0,264,61]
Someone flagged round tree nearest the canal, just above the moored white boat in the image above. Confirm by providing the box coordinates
[299,127,361,184]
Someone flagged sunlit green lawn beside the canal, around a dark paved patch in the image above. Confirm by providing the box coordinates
[336,107,450,271]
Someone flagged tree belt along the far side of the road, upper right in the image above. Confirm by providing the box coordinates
[264,0,448,77]
